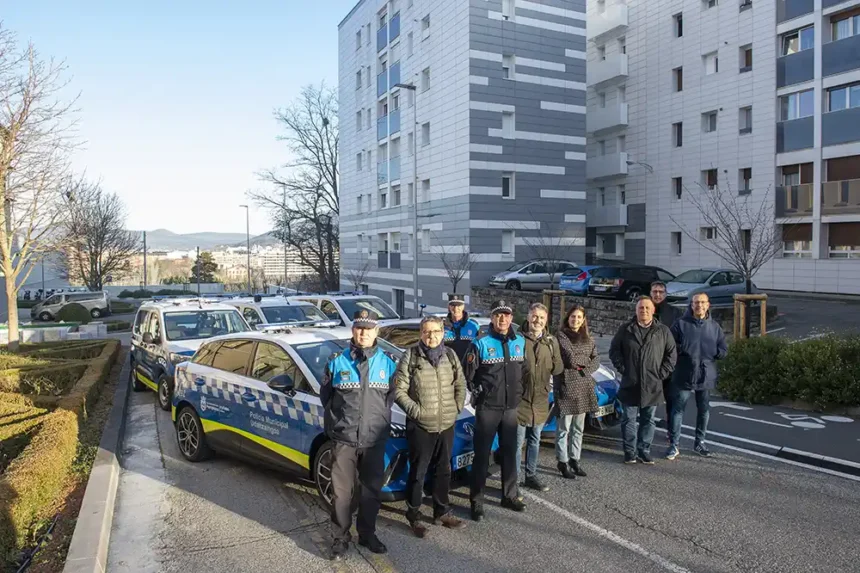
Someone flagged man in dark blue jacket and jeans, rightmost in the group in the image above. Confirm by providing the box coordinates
[666,293,728,460]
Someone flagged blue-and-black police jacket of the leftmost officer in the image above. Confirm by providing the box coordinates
[320,345,397,448]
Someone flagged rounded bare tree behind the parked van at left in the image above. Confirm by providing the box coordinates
[59,176,141,291]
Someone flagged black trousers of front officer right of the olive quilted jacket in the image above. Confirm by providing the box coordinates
[469,409,518,502]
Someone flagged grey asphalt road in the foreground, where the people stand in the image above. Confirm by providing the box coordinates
[108,392,860,573]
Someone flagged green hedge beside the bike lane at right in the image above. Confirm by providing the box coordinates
[718,335,860,409]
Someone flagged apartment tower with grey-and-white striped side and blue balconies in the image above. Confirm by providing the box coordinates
[339,0,586,315]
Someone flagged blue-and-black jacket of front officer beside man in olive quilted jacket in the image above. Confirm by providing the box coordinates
[463,326,528,410]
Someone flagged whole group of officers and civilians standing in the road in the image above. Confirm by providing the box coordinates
[320,283,726,560]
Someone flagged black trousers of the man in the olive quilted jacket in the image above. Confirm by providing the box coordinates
[406,420,454,522]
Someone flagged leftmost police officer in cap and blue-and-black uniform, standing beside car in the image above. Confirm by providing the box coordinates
[320,310,396,560]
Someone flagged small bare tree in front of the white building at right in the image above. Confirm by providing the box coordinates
[670,181,782,294]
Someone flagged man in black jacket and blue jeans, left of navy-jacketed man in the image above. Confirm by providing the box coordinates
[609,296,675,465]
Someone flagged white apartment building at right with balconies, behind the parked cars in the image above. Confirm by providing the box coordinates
[587,0,860,293]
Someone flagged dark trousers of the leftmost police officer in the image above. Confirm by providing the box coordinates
[331,442,385,541]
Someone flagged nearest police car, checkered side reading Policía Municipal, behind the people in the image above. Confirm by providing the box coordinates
[172,327,474,505]
